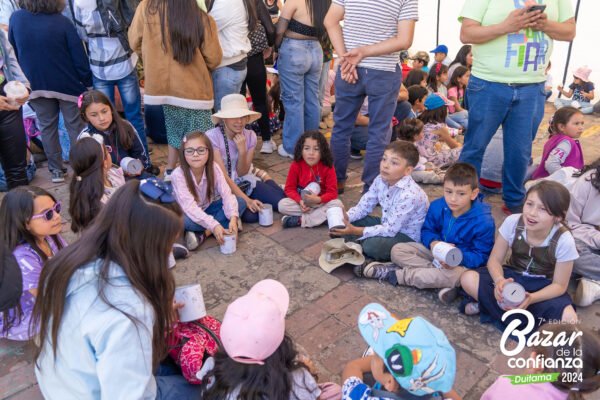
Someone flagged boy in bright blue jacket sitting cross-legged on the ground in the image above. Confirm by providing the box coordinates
[362,163,496,303]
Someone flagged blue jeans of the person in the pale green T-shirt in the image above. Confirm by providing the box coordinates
[460,76,546,208]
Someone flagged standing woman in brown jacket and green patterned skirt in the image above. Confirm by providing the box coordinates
[129,0,224,179]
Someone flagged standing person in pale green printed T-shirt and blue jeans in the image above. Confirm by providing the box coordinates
[460,0,575,213]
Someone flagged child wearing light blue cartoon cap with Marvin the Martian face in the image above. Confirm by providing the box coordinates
[342,303,460,400]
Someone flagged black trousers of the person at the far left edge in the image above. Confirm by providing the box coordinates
[0,109,29,190]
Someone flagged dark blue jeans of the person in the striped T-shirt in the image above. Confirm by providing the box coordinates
[330,66,402,185]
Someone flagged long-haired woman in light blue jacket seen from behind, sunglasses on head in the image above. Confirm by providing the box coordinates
[32,178,198,399]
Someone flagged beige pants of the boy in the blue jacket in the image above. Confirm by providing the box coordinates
[391,242,466,289]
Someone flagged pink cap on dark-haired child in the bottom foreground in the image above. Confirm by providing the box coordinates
[221,279,290,365]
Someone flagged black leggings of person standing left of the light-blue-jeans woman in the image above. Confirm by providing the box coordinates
[242,52,271,142]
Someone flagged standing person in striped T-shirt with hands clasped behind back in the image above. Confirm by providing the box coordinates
[326,0,418,192]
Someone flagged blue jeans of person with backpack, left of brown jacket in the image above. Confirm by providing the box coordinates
[94,68,150,154]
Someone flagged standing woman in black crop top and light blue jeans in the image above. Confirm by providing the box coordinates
[275,0,331,158]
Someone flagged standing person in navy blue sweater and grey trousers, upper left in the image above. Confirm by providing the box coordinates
[8,0,92,183]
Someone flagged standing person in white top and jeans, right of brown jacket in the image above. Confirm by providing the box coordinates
[206,0,258,112]
